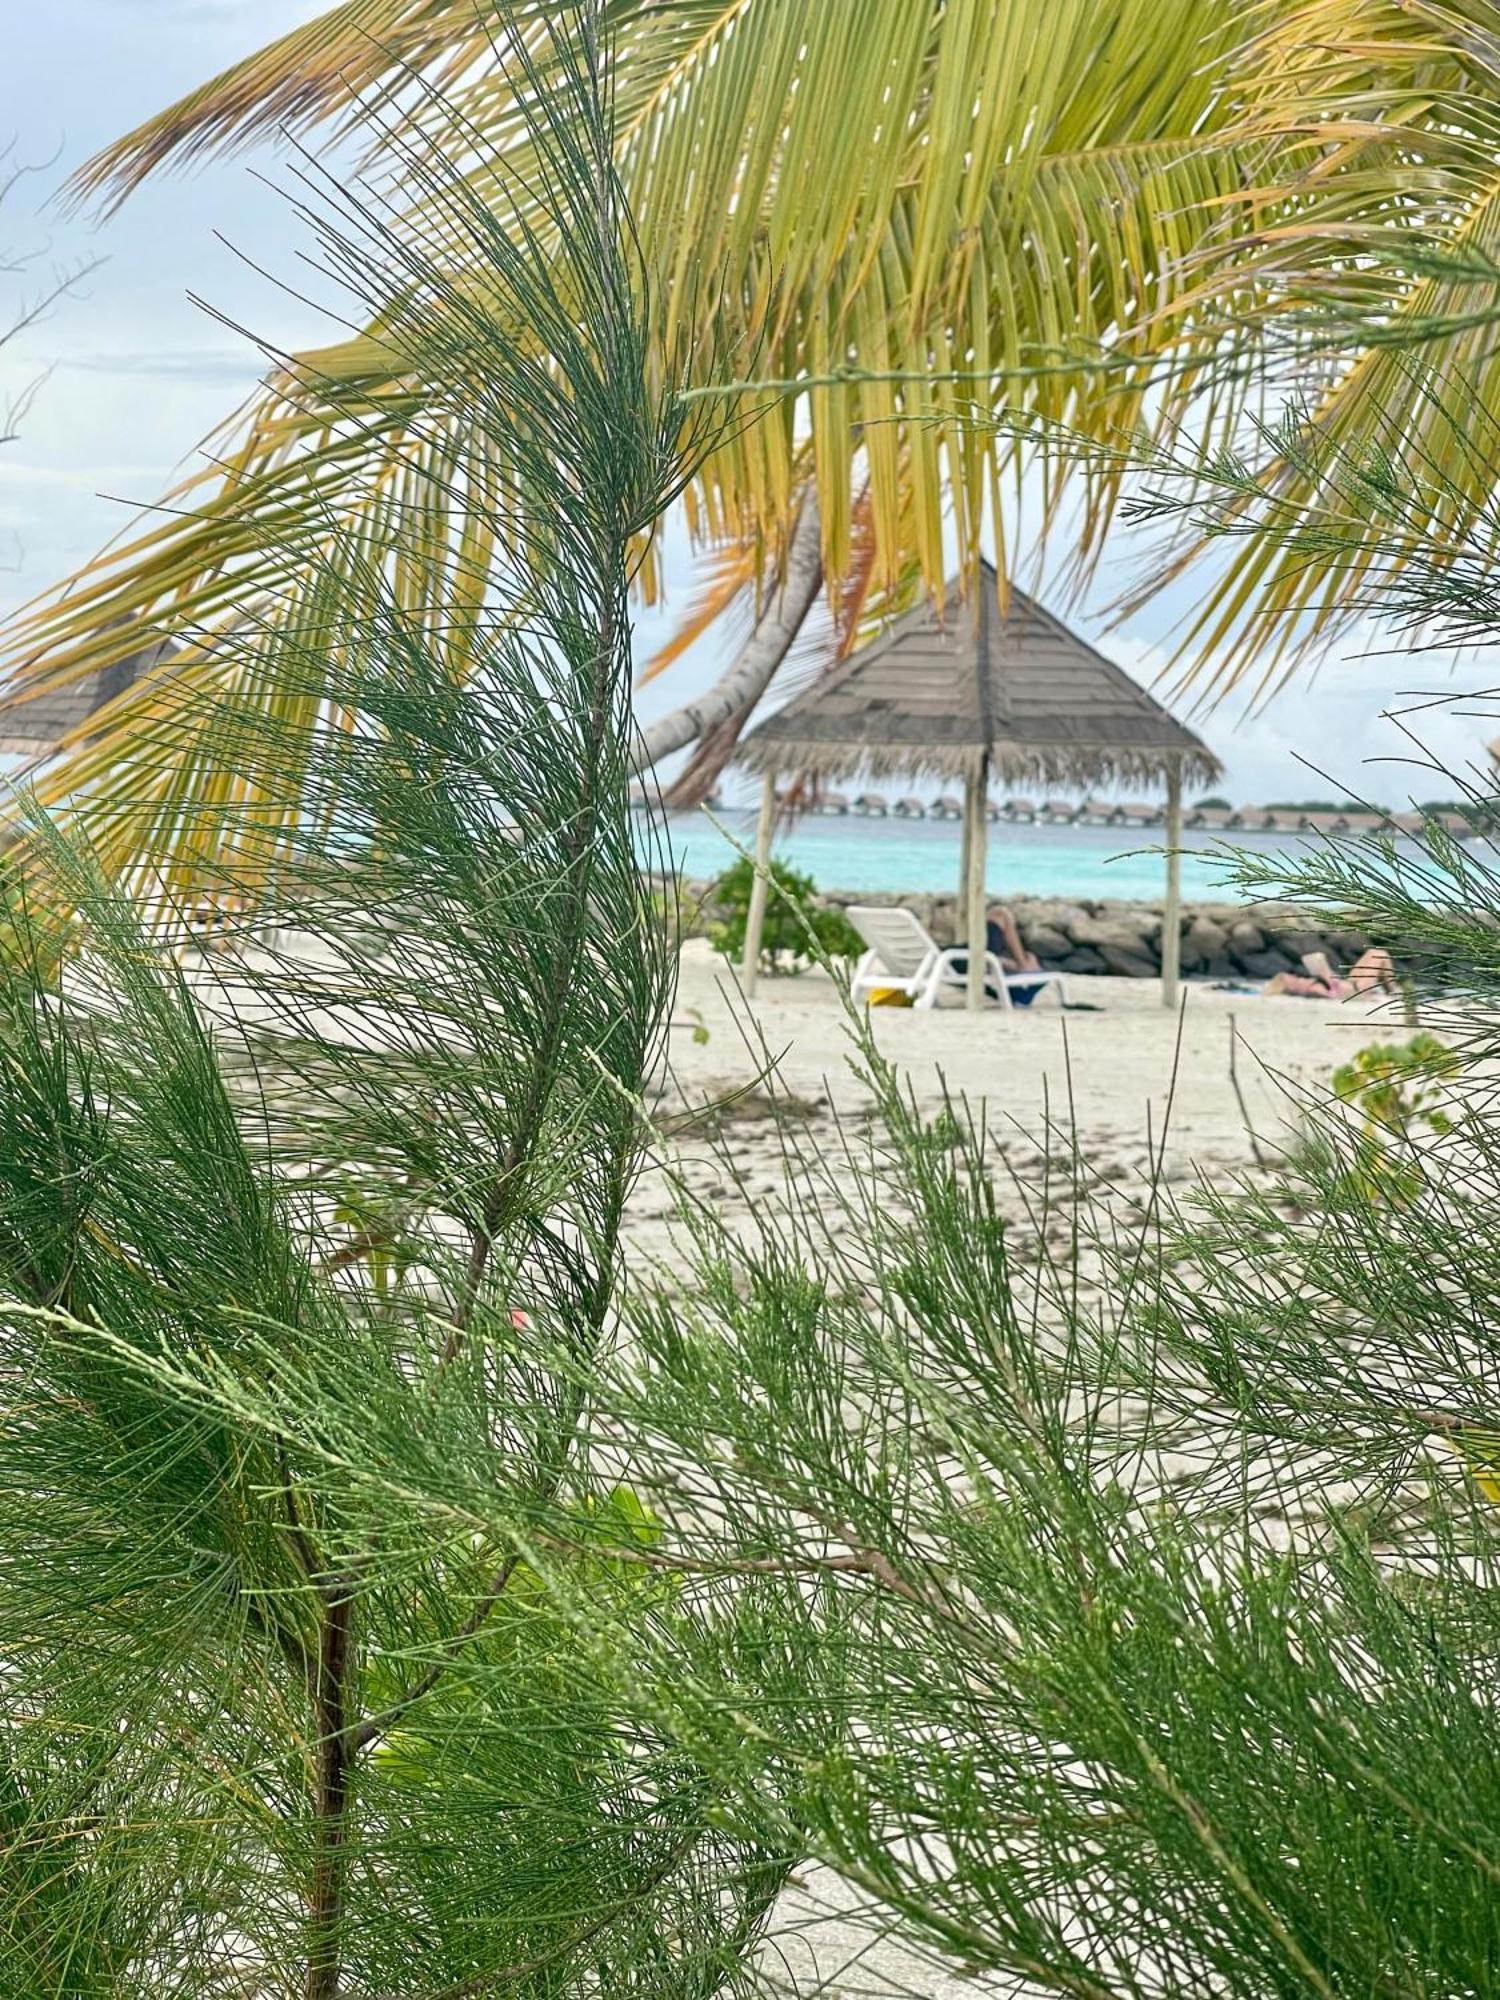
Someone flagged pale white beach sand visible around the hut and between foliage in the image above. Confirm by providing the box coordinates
[628,942,1410,2000]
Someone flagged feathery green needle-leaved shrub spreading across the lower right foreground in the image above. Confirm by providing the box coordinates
[614,792,1500,2000]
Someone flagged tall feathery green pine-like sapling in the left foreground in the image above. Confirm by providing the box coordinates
[0,8,800,2000]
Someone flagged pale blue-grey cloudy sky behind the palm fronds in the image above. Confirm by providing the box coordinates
[0,0,1500,804]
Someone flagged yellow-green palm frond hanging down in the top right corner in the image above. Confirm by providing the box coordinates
[1140,0,1500,694]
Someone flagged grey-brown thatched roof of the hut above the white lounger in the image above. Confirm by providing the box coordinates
[740,564,1220,788]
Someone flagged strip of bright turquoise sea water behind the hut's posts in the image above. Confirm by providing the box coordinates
[652,810,1306,902]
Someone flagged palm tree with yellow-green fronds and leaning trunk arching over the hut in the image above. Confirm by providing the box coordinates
[10,0,1494,892]
